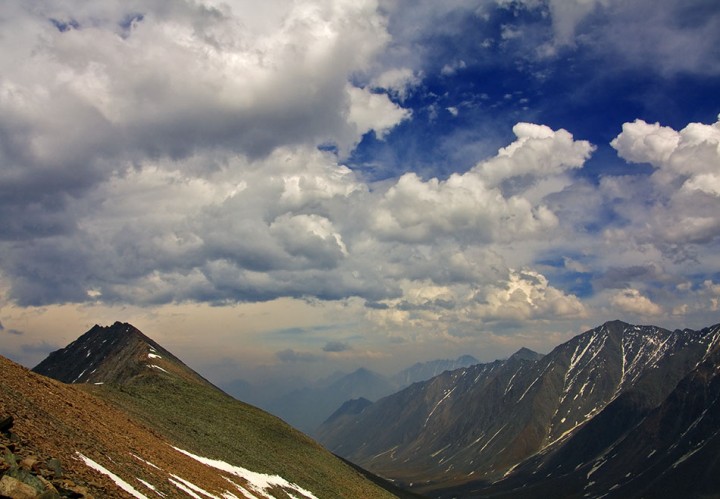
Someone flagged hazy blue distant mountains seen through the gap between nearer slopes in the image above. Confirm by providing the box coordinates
[222,355,479,435]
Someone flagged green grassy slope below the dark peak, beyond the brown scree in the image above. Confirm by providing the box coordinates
[85,372,394,499]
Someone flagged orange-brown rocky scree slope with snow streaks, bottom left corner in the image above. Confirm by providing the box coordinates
[0,357,318,499]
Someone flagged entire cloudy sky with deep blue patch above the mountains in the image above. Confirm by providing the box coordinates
[0,0,720,383]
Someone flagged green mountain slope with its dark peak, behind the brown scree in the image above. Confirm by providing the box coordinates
[35,323,400,497]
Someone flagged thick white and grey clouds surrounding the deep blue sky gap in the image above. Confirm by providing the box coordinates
[0,0,720,368]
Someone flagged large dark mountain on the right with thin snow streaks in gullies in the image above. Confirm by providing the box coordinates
[318,321,720,497]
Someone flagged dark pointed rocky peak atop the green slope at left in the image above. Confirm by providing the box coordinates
[33,321,209,384]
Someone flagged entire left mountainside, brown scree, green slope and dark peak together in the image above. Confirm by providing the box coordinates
[8,322,412,499]
